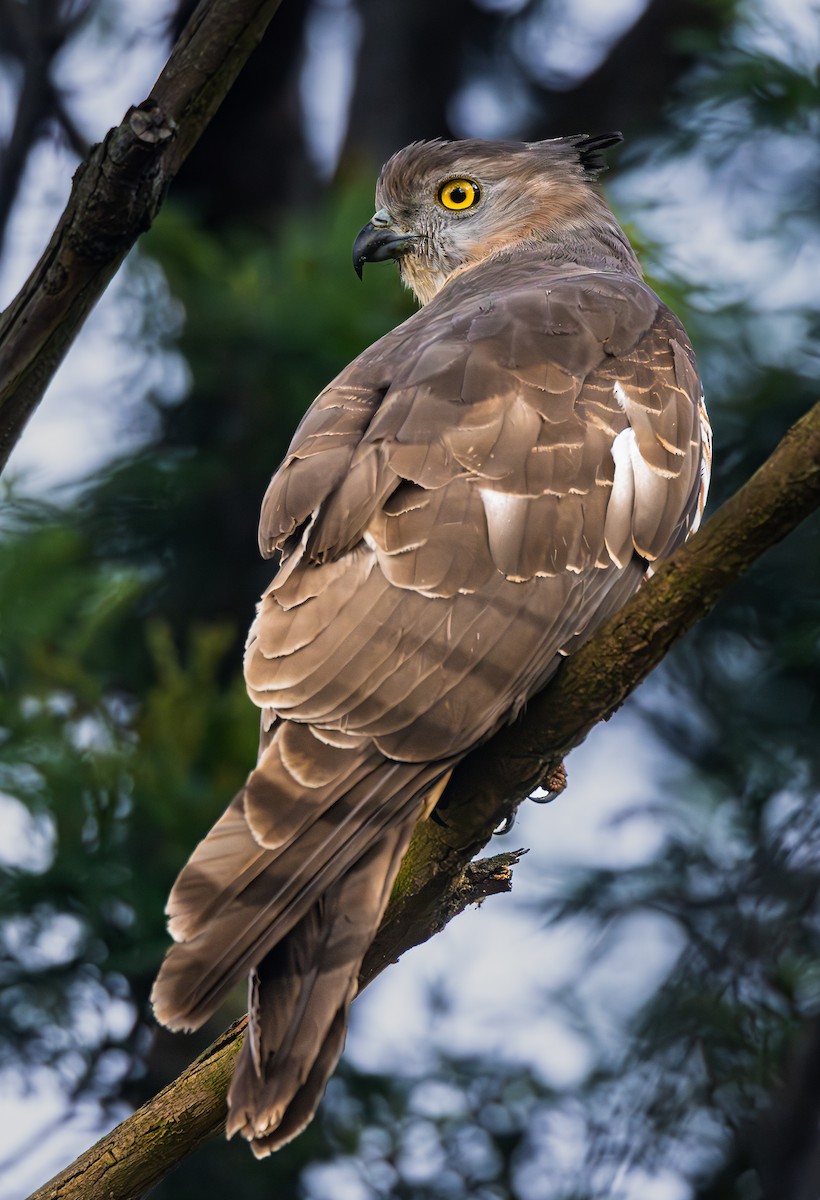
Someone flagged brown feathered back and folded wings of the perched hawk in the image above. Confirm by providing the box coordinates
[246,260,701,762]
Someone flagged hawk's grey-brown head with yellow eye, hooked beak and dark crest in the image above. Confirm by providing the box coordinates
[353,133,634,304]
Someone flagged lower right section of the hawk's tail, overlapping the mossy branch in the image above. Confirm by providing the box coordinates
[228,816,415,1157]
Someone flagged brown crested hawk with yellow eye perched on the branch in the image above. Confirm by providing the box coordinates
[152,133,711,1157]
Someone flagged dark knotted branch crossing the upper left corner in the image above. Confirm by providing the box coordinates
[0,0,285,469]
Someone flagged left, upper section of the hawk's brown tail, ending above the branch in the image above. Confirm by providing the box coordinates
[151,733,451,1030]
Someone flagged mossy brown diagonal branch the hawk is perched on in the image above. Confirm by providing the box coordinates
[30,404,820,1200]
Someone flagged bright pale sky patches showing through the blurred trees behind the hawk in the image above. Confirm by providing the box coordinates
[0,0,820,1200]
